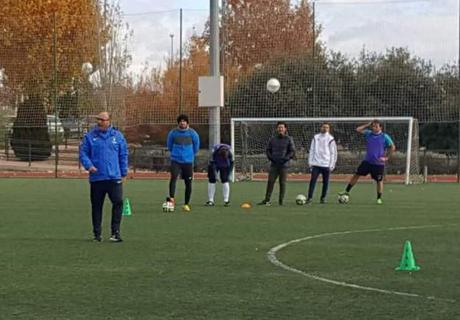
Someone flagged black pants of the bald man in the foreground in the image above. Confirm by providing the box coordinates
[91,180,123,236]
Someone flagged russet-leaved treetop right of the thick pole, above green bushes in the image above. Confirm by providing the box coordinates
[221,0,318,73]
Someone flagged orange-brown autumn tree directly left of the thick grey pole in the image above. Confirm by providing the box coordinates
[122,35,209,144]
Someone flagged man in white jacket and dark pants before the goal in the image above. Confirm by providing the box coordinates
[307,123,337,203]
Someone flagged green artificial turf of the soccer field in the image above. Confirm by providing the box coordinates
[0,179,460,320]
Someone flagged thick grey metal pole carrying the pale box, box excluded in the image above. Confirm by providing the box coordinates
[209,0,220,150]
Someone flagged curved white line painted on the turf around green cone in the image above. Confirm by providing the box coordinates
[267,225,456,302]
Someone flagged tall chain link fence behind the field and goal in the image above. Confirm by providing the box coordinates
[0,0,460,180]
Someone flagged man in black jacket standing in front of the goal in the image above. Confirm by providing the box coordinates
[258,121,295,206]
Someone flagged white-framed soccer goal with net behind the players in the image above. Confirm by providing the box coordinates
[231,117,421,184]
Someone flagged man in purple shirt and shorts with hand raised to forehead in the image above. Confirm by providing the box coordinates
[339,120,396,204]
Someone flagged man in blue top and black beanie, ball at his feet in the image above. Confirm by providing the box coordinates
[166,114,200,212]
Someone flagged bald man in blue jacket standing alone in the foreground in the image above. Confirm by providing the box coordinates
[80,112,128,242]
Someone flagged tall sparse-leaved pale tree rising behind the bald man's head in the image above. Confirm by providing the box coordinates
[54,0,132,130]
